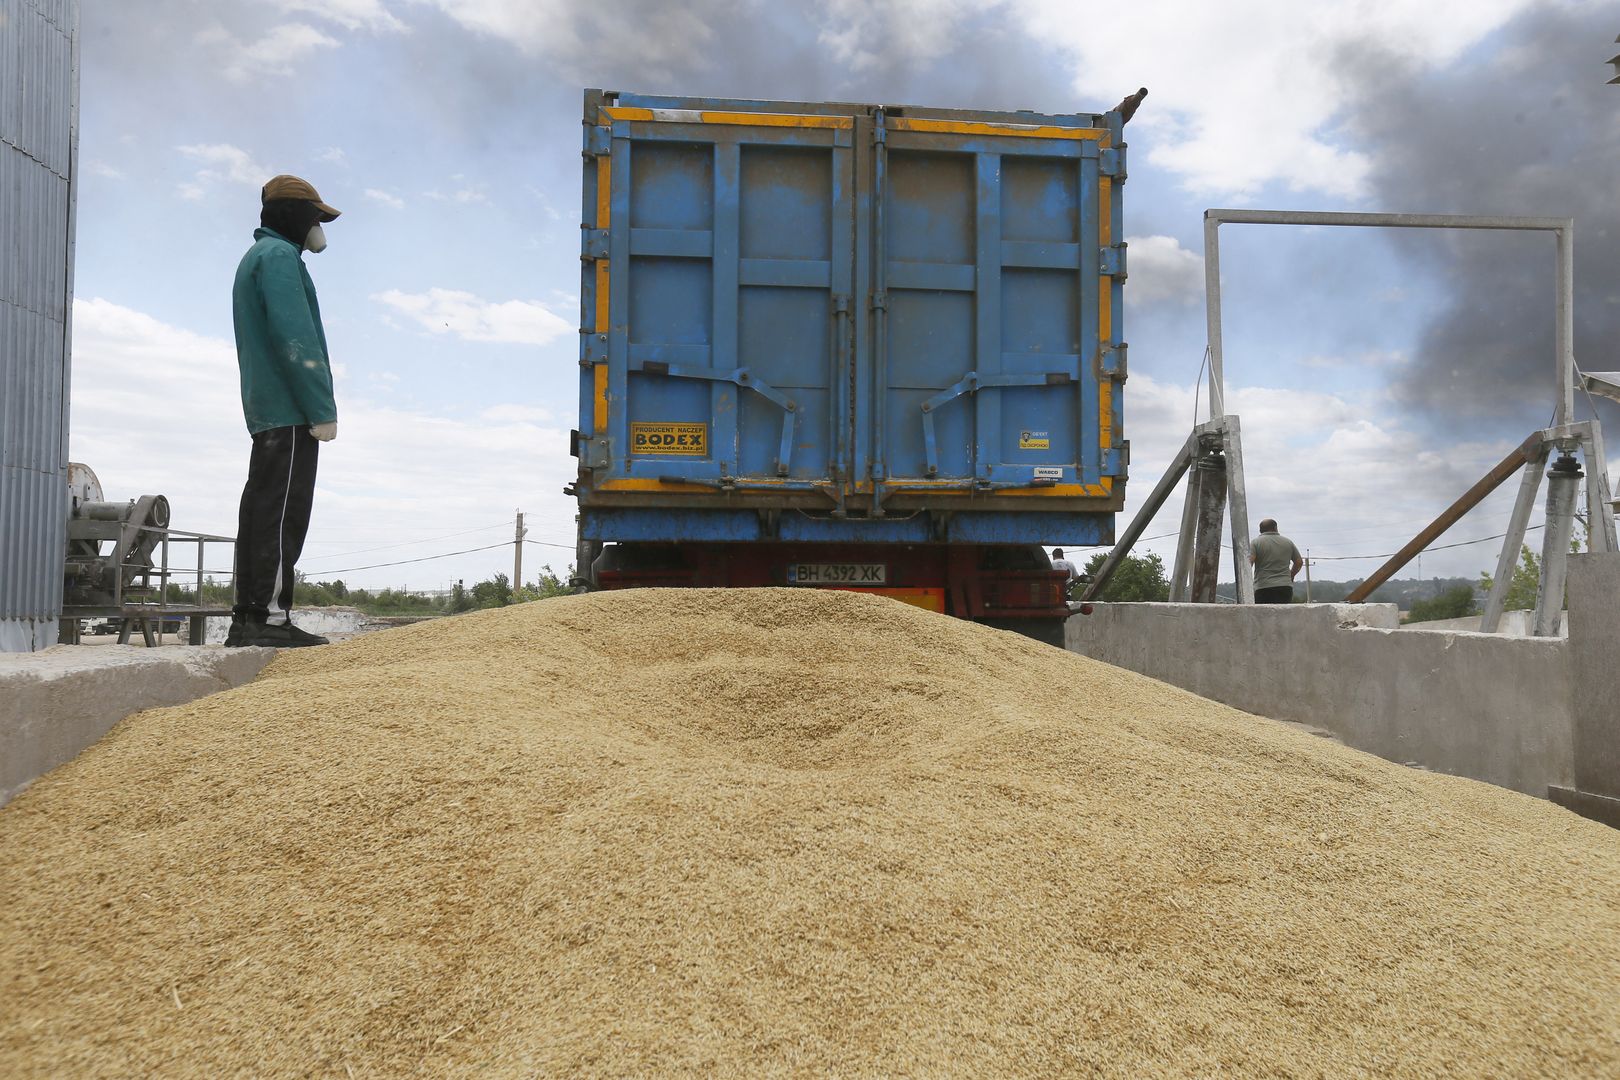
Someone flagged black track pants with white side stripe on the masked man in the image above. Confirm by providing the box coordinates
[232,424,321,622]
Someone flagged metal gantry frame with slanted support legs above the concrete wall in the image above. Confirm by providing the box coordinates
[1082,209,1620,636]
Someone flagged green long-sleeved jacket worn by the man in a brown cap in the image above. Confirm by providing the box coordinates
[230,228,337,434]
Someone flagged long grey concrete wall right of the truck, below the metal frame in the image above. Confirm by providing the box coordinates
[1068,605,1568,798]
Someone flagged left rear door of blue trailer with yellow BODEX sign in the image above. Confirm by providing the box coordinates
[582,105,855,492]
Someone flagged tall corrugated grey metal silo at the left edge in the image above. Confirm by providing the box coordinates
[0,0,79,651]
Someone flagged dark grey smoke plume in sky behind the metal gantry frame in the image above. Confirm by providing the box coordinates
[1349,5,1620,429]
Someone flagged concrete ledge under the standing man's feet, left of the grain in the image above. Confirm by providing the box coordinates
[0,644,275,806]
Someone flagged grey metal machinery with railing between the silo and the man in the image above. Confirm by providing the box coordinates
[58,461,232,644]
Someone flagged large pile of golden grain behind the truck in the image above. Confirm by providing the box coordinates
[0,589,1620,1077]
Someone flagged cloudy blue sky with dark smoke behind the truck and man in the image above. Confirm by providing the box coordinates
[73,0,1620,588]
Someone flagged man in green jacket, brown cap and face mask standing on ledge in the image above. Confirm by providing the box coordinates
[225,175,337,648]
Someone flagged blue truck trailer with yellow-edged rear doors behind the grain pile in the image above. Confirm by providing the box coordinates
[570,91,1129,640]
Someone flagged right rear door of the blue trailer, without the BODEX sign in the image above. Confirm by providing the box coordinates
[855,110,1123,508]
